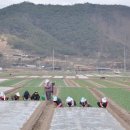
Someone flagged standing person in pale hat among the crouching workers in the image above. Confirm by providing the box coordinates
[44,79,55,100]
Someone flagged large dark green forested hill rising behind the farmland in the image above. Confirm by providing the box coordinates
[0,2,130,58]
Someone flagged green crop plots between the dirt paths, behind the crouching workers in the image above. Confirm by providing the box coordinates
[0,78,130,111]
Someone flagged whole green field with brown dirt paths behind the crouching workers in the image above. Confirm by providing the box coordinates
[0,72,130,130]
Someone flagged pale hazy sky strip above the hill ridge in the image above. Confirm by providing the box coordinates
[0,0,130,8]
